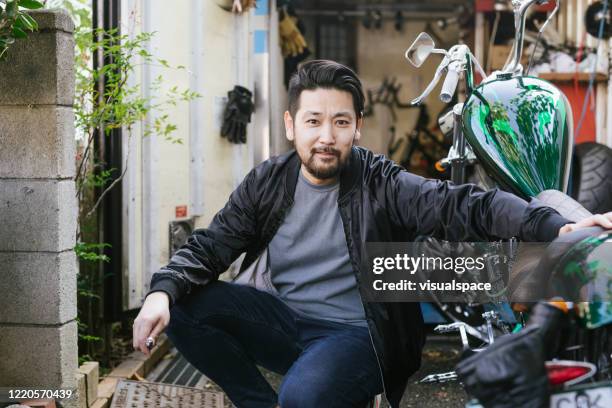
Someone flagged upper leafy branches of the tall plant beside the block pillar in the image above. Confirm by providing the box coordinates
[74,29,200,238]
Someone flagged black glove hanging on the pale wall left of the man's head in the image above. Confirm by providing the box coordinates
[221,85,255,143]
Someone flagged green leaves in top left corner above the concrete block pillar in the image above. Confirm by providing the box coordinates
[0,0,44,60]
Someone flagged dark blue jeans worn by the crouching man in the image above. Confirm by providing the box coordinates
[166,281,382,408]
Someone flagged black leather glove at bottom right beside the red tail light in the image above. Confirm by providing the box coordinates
[456,303,565,408]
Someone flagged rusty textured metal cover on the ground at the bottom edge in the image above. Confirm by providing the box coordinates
[111,380,223,408]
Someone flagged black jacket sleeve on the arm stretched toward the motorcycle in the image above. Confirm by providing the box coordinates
[386,171,570,242]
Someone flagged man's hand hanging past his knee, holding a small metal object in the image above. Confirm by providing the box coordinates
[132,292,170,355]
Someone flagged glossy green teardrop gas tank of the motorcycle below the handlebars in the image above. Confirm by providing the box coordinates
[462,74,573,198]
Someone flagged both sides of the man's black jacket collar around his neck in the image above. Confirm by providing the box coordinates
[285,146,361,202]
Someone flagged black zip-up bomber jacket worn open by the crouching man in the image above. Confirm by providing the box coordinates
[149,147,568,407]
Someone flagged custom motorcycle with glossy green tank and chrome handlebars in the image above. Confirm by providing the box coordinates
[405,0,612,406]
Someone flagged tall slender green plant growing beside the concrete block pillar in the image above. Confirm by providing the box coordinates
[47,0,199,365]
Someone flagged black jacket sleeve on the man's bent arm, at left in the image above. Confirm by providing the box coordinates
[147,170,257,305]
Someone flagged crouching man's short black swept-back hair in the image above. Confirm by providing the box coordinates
[288,60,365,119]
